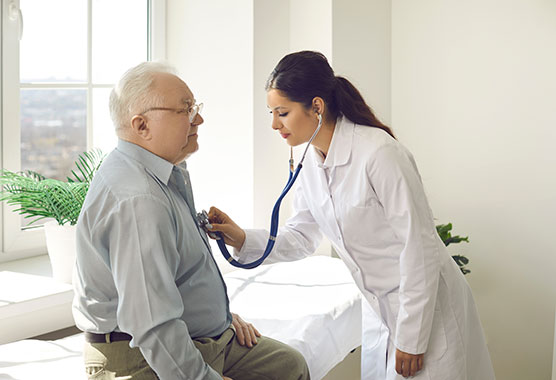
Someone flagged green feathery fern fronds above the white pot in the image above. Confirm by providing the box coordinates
[0,149,104,225]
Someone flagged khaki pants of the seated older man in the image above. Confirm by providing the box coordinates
[83,328,309,380]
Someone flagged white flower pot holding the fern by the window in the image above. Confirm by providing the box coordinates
[44,221,76,284]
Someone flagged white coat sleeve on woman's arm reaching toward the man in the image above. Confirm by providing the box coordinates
[235,182,322,264]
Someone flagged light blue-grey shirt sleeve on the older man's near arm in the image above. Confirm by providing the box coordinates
[96,195,222,380]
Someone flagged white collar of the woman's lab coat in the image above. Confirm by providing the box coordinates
[314,116,355,169]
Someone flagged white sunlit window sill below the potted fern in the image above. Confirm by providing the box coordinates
[0,255,74,344]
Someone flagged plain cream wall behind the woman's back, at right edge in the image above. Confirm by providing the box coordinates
[392,0,556,380]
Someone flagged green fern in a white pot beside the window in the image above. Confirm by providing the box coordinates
[0,149,104,283]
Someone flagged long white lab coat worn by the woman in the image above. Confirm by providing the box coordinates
[239,118,494,380]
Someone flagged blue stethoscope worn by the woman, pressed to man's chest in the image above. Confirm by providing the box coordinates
[197,113,322,269]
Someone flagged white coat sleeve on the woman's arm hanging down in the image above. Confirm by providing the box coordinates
[367,144,440,354]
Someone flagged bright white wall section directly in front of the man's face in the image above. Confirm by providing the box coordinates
[166,0,254,268]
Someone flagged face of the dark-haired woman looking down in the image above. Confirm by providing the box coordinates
[266,89,318,146]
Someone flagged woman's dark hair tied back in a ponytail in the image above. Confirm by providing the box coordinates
[265,51,395,138]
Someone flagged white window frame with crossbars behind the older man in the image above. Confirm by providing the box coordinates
[0,0,166,262]
